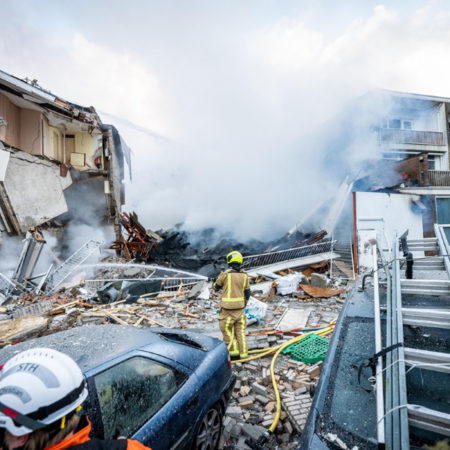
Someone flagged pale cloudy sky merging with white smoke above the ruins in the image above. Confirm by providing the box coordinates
[0,0,450,241]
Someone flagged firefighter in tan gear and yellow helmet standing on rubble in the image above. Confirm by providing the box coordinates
[213,251,250,360]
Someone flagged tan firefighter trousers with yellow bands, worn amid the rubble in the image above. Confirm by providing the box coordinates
[219,308,248,359]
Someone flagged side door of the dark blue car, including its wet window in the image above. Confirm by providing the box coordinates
[88,351,200,450]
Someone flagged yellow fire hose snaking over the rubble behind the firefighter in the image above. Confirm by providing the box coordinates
[228,319,337,433]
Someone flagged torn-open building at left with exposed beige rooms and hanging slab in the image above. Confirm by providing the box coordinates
[0,71,131,237]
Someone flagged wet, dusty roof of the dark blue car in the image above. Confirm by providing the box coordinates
[0,325,161,372]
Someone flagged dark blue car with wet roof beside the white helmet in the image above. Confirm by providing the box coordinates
[0,325,235,450]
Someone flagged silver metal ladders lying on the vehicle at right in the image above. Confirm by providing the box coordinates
[374,226,450,450]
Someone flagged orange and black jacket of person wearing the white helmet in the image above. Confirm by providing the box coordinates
[45,417,150,450]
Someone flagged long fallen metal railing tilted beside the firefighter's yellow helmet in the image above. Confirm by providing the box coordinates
[242,241,336,269]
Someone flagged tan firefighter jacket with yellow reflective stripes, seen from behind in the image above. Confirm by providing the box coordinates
[214,269,250,309]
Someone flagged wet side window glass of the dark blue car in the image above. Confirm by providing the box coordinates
[94,357,186,439]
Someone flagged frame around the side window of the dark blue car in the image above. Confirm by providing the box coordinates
[85,350,193,439]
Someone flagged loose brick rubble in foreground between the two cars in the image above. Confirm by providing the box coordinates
[221,356,322,450]
